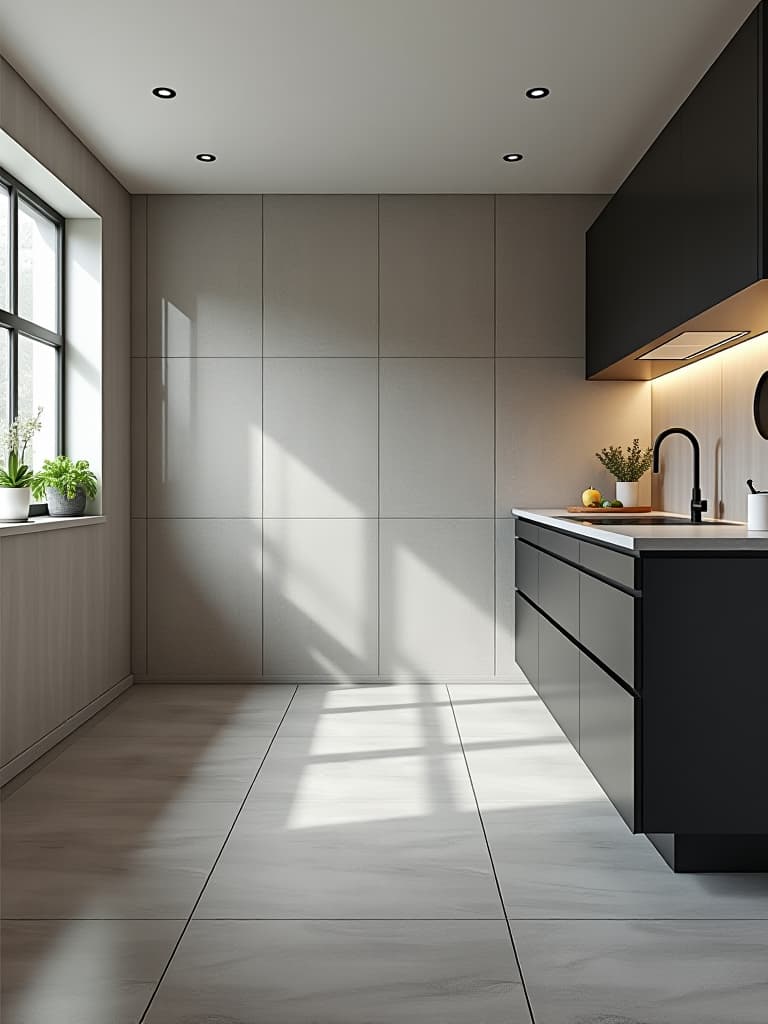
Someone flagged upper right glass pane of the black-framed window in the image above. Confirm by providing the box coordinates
[18,200,57,331]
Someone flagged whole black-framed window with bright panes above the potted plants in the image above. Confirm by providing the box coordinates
[0,169,65,512]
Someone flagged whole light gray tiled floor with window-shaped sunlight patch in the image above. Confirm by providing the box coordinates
[0,682,768,1024]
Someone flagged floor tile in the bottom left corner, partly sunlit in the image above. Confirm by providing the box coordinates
[0,921,183,1024]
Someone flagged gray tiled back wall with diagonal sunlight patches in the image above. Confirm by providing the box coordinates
[133,196,650,680]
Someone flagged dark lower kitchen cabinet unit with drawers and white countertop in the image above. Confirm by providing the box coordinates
[512,509,768,871]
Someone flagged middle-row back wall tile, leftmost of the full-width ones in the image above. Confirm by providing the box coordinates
[147,358,261,518]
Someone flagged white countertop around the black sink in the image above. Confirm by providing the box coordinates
[512,509,768,551]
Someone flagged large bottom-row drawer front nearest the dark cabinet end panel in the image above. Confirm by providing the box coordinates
[580,654,639,831]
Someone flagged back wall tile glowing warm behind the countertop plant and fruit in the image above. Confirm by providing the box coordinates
[497,358,650,516]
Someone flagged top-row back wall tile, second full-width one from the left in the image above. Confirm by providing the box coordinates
[264,196,379,355]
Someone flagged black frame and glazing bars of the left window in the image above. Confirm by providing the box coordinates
[0,167,67,515]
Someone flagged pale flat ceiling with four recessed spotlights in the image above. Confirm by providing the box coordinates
[0,0,755,193]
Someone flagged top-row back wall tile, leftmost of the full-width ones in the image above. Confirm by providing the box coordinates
[146,196,261,356]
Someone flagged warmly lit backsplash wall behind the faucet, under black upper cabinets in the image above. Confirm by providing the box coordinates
[652,335,768,520]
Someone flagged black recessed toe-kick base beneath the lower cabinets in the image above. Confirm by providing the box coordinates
[646,833,768,872]
